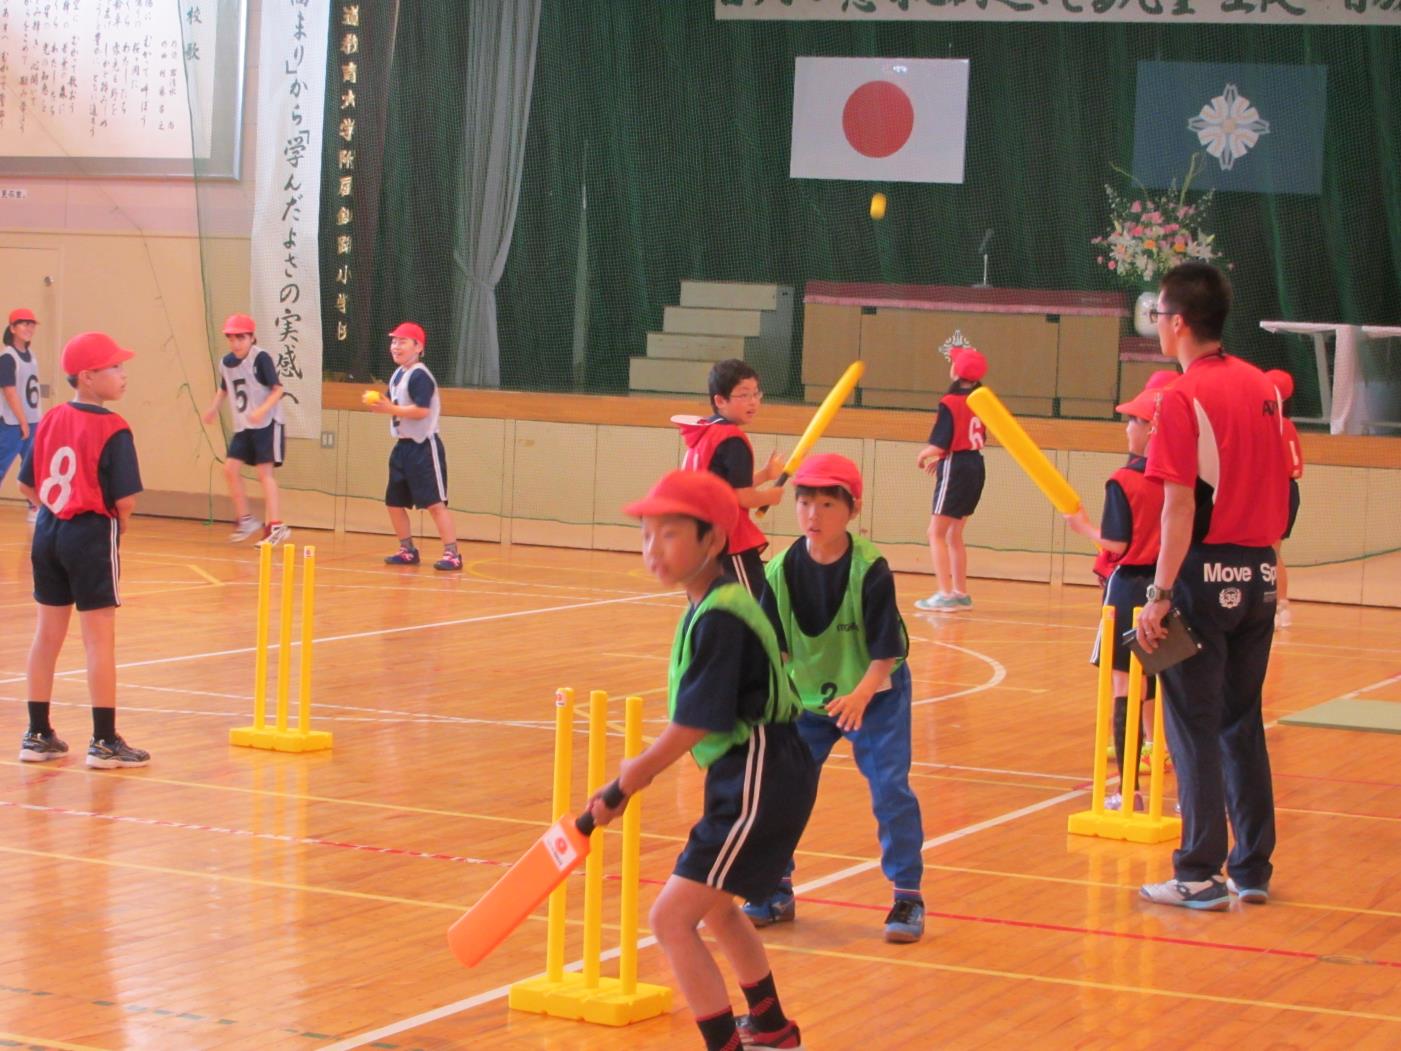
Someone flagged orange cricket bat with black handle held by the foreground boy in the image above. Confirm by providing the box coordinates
[447,781,623,967]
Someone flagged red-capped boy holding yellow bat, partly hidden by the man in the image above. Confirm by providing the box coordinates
[1065,369,1178,810]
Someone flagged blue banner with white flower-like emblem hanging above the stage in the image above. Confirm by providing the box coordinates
[1133,62,1328,193]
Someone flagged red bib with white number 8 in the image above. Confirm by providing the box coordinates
[32,404,130,518]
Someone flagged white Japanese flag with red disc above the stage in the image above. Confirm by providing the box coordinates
[789,59,968,182]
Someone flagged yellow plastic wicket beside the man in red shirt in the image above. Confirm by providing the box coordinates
[1066,605,1182,844]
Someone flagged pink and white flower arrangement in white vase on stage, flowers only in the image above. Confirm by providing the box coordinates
[1090,154,1231,286]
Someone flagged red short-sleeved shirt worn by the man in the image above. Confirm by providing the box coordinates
[1145,353,1289,548]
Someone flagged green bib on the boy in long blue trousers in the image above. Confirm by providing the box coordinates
[764,534,909,715]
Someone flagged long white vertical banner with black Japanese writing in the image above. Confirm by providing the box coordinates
[248,0,331,437]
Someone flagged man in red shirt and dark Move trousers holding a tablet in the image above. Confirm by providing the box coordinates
[1138,262,1289,909]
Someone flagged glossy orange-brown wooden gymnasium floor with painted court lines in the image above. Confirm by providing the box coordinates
[0,507,1401,1051]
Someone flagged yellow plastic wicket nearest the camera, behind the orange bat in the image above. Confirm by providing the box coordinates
[509,689,671,1026]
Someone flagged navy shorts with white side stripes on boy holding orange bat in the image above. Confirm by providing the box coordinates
[672,723,817,900]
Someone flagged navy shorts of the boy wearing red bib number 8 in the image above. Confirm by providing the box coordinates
[29,507,122,612]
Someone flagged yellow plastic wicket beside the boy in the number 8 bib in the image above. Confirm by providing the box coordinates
[228,544,331,751]
